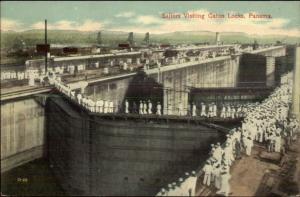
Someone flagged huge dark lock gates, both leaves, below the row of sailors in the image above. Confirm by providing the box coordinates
[47,95,225,195]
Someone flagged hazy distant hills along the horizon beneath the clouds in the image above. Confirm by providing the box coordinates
[1,30,300,49]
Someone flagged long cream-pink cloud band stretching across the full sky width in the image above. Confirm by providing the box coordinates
[1,9,300,37]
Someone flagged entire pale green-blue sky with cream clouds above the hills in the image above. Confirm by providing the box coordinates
[1,1,300,36]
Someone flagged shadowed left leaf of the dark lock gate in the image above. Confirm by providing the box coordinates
[46,97,92,195]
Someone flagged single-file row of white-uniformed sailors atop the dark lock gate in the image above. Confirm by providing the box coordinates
[49,73,258,119]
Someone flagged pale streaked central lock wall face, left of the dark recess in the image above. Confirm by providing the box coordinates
[150,57,240,114]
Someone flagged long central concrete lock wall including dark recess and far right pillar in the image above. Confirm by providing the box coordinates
[146,46,285,114]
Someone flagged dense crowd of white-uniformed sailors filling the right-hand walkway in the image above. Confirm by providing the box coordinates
[157,73,299,196]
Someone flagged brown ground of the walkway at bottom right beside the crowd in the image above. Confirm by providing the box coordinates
[196,134,300,196]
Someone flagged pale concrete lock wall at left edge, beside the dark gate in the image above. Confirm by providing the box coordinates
[1,98,45,173]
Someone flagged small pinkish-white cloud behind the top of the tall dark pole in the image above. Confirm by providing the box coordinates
[31,20,104,31]
